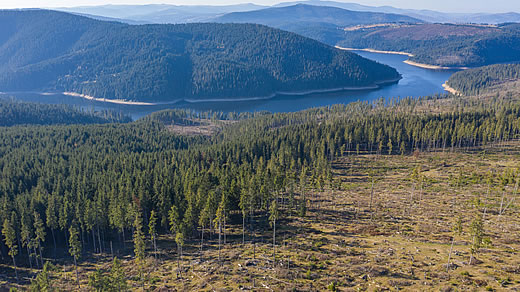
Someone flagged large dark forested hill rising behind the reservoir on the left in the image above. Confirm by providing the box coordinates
[0,10,399,101]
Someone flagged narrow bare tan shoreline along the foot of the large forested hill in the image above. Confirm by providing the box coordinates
[60,76,402,106]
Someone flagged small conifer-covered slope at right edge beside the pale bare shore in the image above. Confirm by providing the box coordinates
[448,64,520,95]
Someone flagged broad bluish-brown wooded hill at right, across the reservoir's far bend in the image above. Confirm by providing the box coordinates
[338,24,520,67]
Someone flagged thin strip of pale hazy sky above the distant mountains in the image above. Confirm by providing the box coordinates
[0,0,520,12]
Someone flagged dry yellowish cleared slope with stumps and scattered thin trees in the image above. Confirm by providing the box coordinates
[4,142,520,291]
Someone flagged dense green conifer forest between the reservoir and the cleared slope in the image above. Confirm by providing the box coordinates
[0,94,520,272]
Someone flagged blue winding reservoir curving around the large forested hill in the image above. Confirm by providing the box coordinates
[4,51,456,119]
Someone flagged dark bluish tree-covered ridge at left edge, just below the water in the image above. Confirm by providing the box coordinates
[0,98,131,127]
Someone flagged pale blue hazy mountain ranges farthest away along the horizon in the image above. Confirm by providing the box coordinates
[58,0,520,24]
